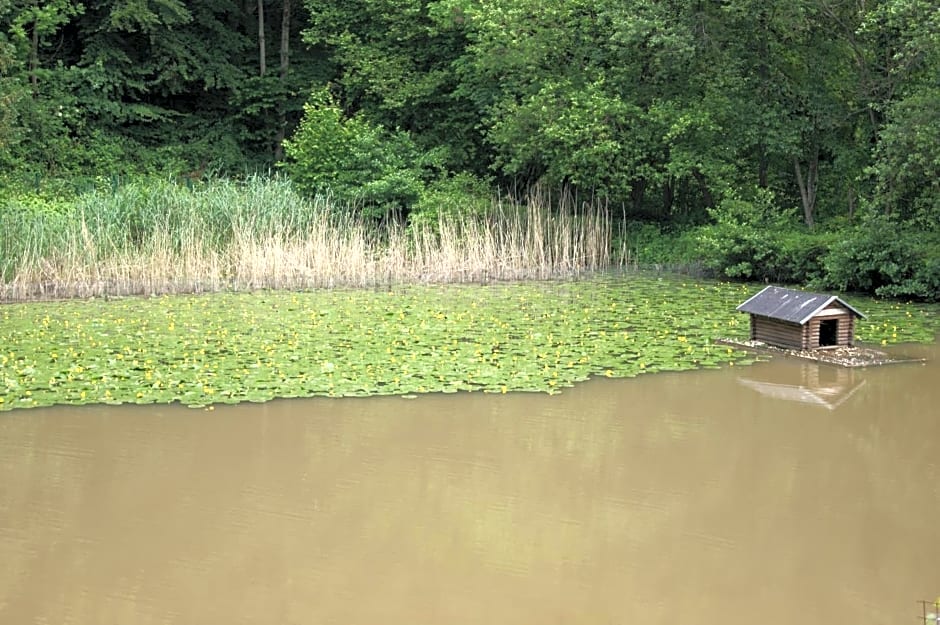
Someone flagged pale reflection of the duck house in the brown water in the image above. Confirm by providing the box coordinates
[738,363,865,410]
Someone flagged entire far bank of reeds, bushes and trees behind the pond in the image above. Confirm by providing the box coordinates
[0,0,940,301]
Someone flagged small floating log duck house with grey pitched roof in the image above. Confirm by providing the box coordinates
[737,286,865,350]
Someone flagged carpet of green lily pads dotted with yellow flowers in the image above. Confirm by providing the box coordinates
[0,276,937,409]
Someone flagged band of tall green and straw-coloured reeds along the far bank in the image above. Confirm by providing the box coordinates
[0,177,611,301]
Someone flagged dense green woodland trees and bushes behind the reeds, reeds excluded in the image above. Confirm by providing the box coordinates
[0,0,940,299]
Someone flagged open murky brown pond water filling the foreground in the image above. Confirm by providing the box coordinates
[0,346,940,625]
